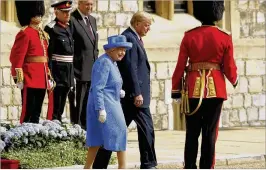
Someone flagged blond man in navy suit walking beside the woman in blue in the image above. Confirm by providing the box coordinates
[93,12,157,169]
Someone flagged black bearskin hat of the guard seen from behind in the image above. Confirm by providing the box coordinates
[193,0,224,24]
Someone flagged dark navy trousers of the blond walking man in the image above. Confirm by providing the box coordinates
[93,99,157,169]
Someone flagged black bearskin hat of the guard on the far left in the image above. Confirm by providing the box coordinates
[15,0,45,27]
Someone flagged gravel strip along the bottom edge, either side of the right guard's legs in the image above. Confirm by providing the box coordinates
[157,160,266,169]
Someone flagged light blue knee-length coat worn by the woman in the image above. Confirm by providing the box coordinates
[86,54,127,151]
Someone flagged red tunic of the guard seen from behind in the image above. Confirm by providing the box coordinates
[172,26,237,99]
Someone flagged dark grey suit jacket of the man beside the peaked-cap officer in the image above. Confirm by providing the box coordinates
[70,10,99,81]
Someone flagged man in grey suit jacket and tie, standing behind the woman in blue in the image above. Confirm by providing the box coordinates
[71,0,99,129]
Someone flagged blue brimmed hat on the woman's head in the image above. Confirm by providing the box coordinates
[103,35,132,50]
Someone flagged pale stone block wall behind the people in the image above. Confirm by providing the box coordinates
[0,0,266,130]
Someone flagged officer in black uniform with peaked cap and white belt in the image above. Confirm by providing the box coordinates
[44,0,74,121]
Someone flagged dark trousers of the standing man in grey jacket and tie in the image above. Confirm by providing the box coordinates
[75,80,91,130]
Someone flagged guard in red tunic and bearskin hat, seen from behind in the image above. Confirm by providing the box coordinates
[172,0,238,169]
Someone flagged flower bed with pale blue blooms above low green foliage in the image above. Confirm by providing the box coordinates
[0,120,114,169]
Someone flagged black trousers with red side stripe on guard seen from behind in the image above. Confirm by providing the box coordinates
[184,98,224,169]
